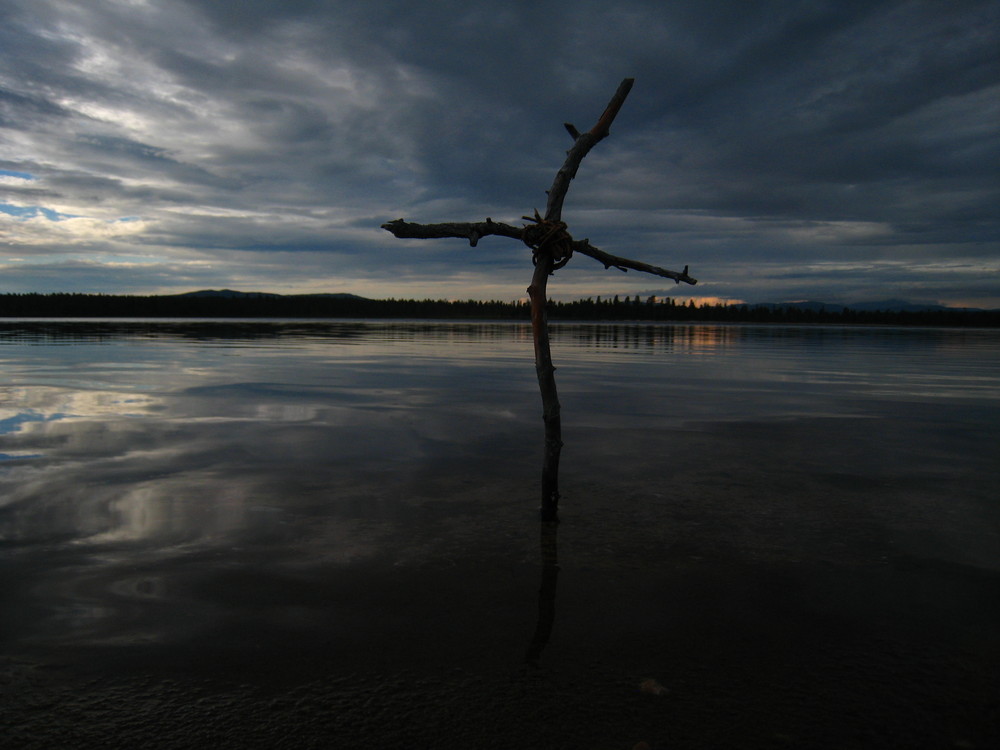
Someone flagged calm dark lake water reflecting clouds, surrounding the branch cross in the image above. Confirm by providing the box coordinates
[0,320,1000,750]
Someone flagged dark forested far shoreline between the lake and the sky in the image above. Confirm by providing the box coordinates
[0,293,1000,327]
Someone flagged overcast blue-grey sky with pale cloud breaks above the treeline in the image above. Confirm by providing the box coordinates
[0,0,1000,307]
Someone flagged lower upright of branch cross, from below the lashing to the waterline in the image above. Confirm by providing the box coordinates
[528,253,562,521]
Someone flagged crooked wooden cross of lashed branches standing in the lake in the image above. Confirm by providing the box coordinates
[382,78,697,521]
